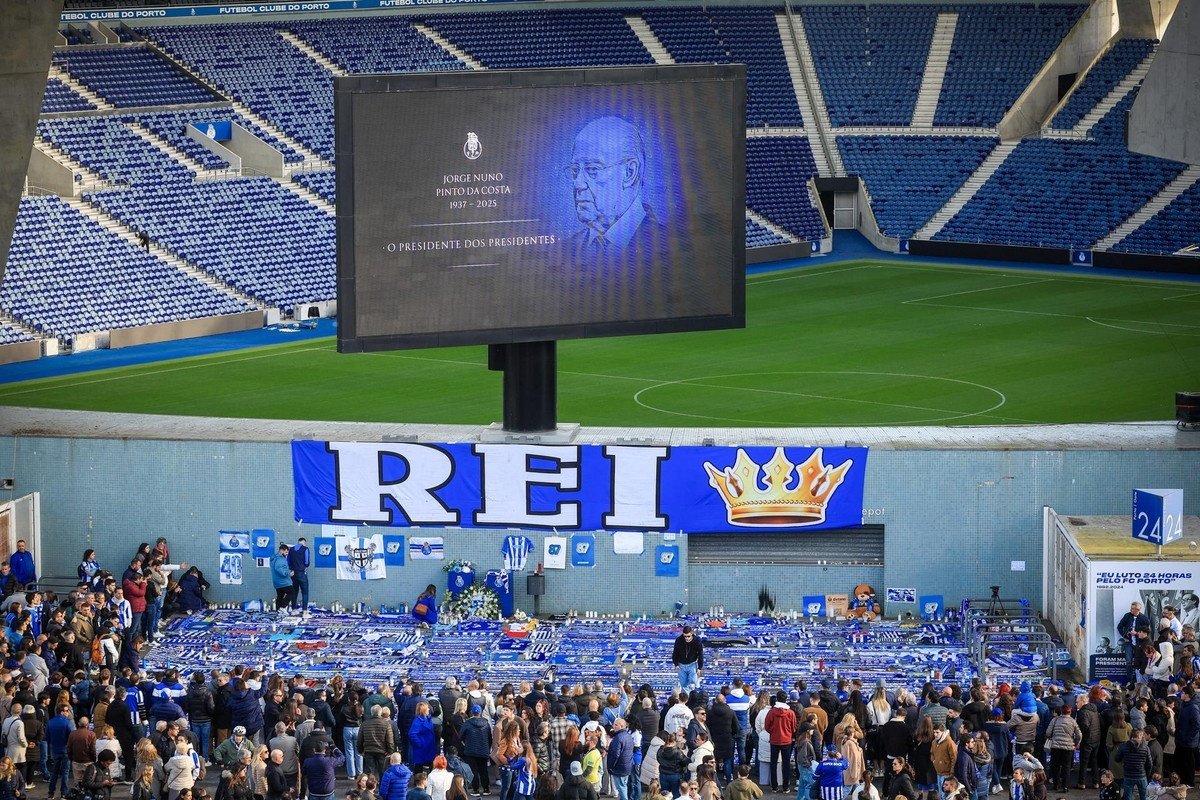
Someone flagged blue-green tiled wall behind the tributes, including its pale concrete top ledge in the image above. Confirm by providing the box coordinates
[0,409,1200,614]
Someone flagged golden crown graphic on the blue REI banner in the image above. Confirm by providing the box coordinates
[704,447,854,527]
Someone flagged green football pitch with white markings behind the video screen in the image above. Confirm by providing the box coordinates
[0,261,1200,427]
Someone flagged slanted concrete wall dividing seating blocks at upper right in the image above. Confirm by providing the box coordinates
[1000,0,1118,142]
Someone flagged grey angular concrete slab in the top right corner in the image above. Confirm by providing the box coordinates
[1129,2,1200,164]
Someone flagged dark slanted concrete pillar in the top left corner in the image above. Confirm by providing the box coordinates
[0,0,62,278]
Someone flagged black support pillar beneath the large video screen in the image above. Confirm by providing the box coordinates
[490,342,558,433]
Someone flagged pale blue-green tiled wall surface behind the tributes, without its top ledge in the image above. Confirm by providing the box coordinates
[0,434,1200,613]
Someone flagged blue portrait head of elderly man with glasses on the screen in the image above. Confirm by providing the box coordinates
[565,116,660,260]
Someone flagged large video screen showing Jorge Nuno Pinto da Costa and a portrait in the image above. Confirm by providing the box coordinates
[335,65,745,351]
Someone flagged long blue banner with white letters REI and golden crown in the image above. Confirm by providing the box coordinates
[292,441,868,534]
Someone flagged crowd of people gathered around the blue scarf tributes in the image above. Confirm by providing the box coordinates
[0,539,1200,800]
